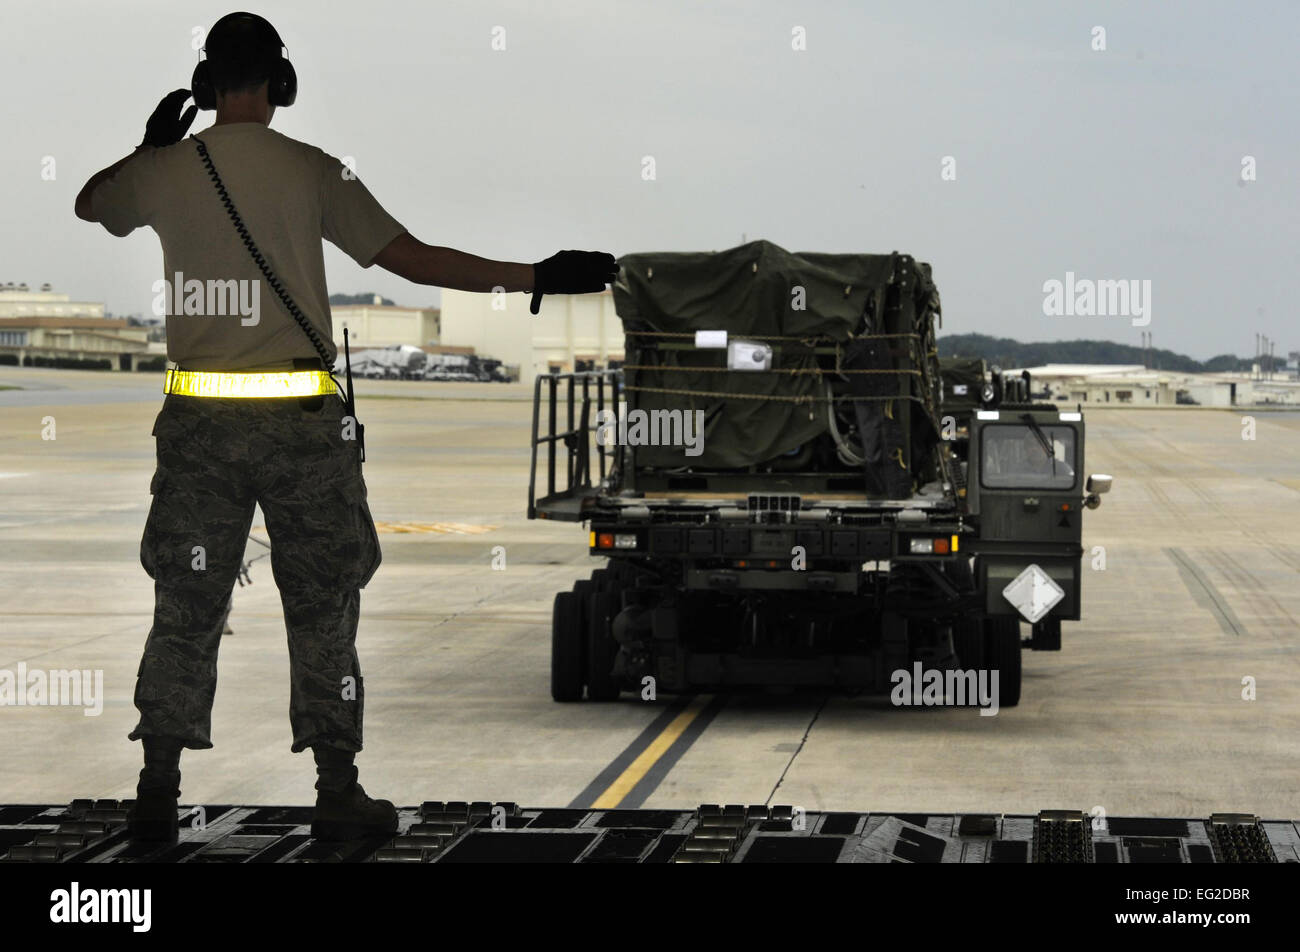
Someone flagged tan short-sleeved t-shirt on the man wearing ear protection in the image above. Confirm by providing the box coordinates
[91,122,406,371]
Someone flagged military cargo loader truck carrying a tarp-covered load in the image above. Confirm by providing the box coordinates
[528,242,1112,707]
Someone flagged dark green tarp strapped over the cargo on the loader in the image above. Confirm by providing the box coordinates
[614,241,939,469]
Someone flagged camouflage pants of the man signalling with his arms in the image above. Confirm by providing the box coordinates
[130,394,381,752]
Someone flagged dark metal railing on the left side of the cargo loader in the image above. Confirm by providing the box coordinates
[528,371,623,522]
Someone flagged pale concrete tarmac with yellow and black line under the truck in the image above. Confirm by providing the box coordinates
[0,367,1300,817]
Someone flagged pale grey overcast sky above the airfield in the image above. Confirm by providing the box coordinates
[0,0,1300,358]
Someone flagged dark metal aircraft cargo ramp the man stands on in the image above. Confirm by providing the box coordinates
[0,800,1300,864]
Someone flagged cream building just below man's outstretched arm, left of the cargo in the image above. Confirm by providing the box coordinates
[442,290,623,384]
